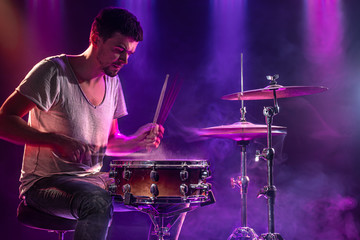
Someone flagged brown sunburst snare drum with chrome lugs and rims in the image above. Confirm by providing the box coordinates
[109,159,212,205]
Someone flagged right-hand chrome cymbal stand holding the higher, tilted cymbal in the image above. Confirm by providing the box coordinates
[256,75,283,240]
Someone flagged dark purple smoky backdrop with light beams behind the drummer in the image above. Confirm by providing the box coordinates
[0,0,360,240]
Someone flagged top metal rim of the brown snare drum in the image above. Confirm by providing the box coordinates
[110,159,209,169]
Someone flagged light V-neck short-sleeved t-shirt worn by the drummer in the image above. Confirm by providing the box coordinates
[16,54,127,195]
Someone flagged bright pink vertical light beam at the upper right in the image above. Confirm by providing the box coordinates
[305,0,344,87]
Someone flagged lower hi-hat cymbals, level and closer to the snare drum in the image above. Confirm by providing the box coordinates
[200,122,286,141]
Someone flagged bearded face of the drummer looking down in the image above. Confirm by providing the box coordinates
[96,33,138,77]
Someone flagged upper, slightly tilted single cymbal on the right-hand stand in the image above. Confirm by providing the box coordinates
[221,84,328,100]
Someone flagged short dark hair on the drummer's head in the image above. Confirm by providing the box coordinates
[90,7,143,42]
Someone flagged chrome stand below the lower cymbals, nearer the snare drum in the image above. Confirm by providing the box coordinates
[228,141,258,240]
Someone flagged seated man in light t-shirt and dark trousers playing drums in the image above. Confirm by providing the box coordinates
[0,8,170,240]
